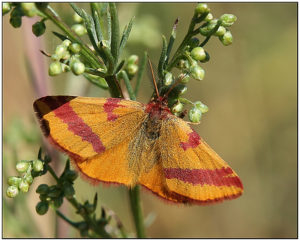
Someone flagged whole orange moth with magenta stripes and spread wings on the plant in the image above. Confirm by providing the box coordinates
[34,68,243,204]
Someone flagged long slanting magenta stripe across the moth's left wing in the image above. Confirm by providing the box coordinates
[53,102,105,153]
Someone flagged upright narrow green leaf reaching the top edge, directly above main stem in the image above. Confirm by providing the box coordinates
[109,2,120,62]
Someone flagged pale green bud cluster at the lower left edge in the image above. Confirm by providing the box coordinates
[6,160,44,198]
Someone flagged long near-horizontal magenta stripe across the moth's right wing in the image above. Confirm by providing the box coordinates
[164,167,243,188]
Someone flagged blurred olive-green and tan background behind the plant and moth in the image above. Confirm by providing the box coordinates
[3,3,297,238]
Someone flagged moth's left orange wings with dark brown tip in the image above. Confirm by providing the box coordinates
[34,96,145,184]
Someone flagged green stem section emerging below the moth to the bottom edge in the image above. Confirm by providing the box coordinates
[129,186,146,238]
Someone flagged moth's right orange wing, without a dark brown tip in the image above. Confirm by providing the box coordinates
[160,116,243,204]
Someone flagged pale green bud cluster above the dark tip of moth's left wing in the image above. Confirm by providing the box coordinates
[48,39,85,76]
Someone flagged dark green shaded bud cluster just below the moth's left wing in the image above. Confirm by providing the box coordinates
[35,161,78,215]
